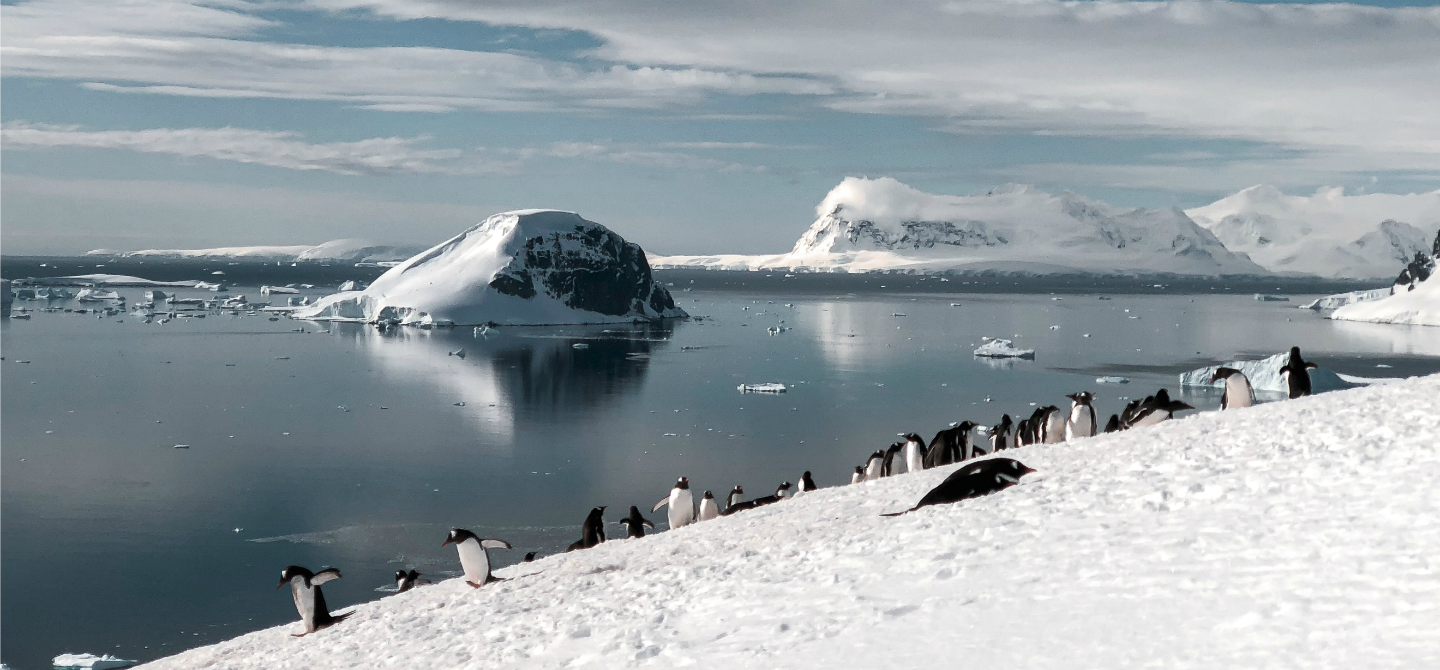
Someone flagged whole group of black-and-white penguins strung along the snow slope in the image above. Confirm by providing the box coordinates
[275,353,1316,637]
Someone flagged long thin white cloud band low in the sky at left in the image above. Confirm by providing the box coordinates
[0,121,514,174]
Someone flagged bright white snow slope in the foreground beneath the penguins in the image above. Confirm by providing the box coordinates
[147,376,1440,670]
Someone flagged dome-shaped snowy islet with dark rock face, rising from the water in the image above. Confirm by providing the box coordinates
[295,209,685,326]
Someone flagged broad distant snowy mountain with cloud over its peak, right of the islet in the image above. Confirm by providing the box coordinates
[657,177,1267,275]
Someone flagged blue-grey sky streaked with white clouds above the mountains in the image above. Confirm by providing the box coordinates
[0,0,1440,255]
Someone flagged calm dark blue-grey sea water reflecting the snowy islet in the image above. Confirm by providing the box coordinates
[0,272,1440,669]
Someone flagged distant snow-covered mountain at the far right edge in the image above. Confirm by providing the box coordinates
[1185,184,1440,280]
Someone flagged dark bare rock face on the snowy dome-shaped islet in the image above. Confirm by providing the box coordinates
[490,226,675,317]
